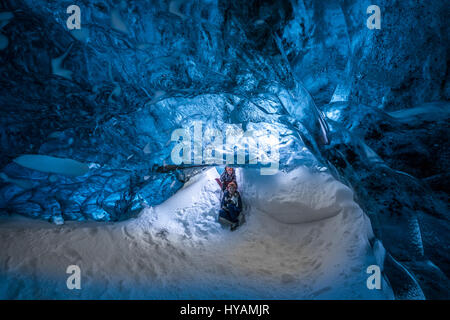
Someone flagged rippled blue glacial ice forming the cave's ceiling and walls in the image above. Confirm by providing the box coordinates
[0,0,450,298]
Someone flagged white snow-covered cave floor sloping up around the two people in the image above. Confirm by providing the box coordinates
[0,168,392,299]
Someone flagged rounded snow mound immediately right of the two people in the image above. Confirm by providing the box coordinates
[243,167,354,223]
